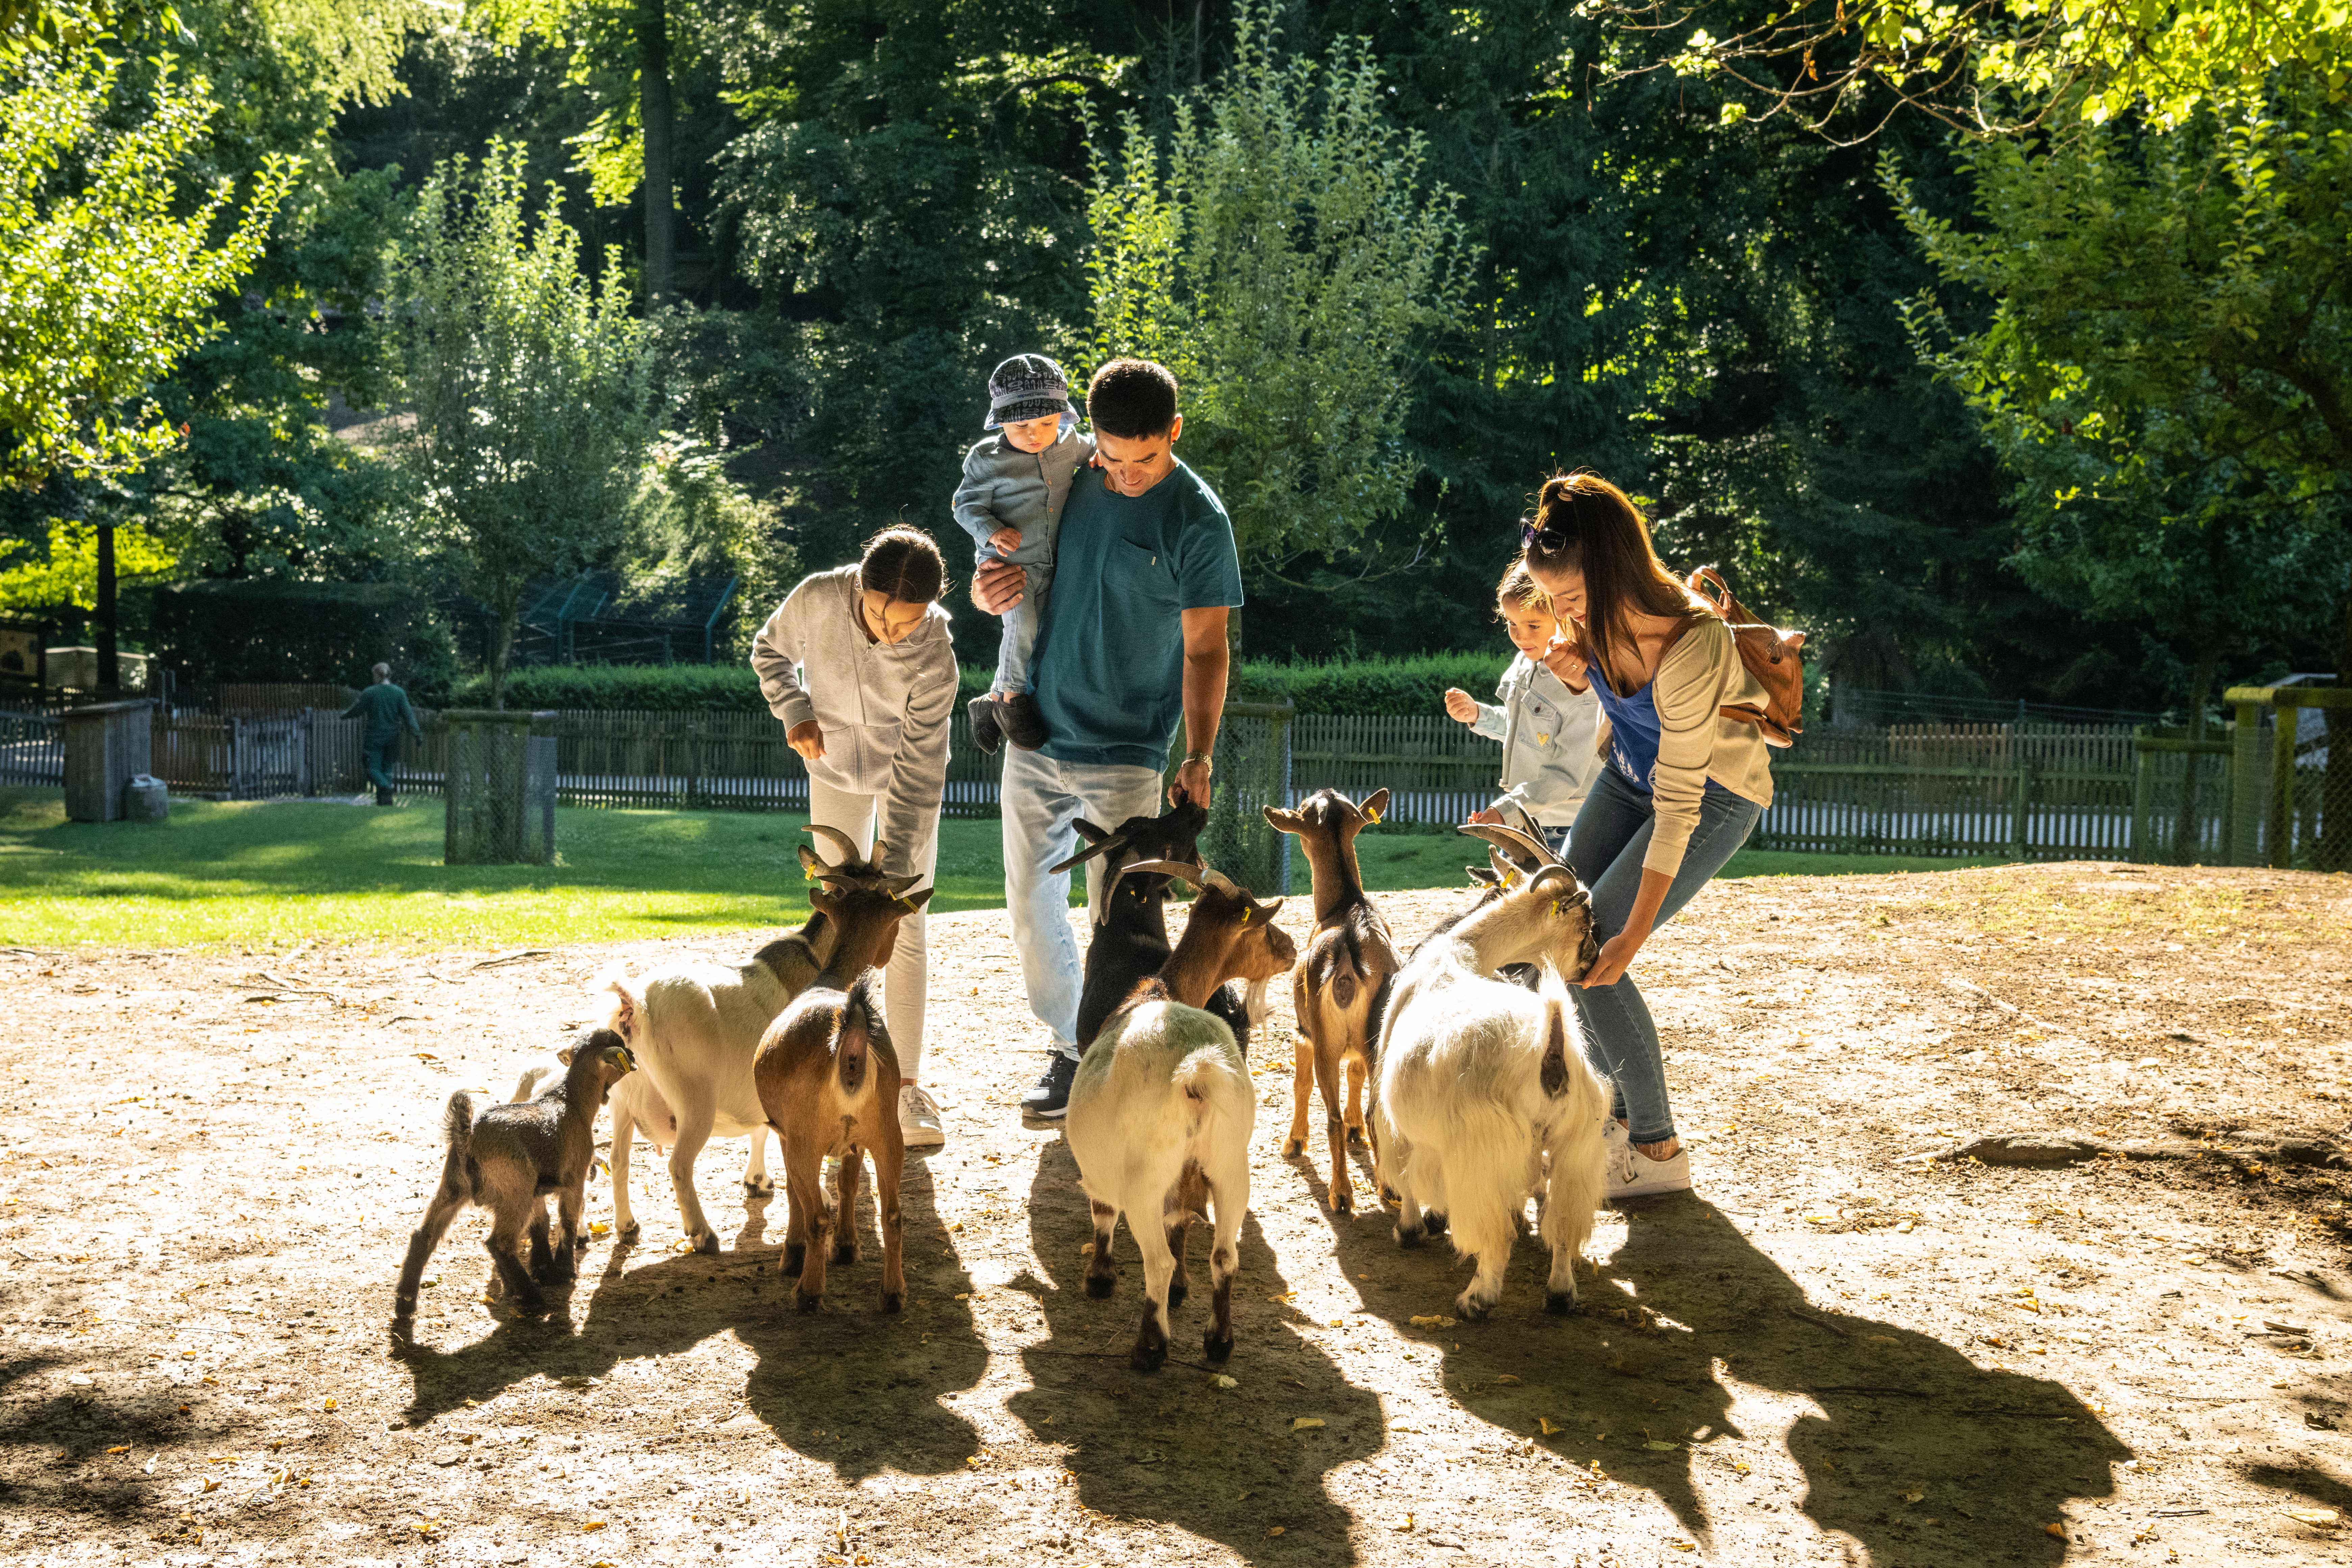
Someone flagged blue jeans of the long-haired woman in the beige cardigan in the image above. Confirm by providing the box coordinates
[1569,769,1764,1143]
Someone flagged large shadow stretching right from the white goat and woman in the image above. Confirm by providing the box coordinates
[1341,1197,2131,1566]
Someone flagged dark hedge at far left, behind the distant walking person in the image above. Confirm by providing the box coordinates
[144,578,456,701]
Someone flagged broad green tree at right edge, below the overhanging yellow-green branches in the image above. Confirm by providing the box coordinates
[1908,80,2352,865]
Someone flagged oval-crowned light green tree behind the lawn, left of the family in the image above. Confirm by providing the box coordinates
[388,143,654,708]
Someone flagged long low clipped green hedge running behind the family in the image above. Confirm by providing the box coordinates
[454,654,1510,715]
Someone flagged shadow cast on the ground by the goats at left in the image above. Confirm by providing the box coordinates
[405,1159,988,1484]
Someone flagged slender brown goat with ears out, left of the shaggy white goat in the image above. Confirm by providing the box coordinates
[1265,790,1404,1213]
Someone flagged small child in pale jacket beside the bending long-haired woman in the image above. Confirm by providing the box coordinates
[1446,562,1604,856]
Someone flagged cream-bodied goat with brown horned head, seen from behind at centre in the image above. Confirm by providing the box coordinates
[1063,860,1298,1373]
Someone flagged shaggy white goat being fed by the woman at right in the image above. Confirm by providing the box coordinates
[1376,828,1609,1319]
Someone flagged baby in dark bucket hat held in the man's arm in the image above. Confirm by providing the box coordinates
[955,355,1094,752]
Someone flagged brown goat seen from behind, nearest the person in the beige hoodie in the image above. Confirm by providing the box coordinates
[750,886,931,1312]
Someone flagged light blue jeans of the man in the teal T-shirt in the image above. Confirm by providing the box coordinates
[1000,750,1159,1058]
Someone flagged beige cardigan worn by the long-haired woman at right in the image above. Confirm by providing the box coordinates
[1642,616,1771,877]
